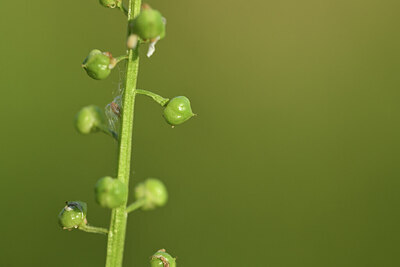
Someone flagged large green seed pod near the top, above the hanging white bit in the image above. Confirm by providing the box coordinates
[130,8,165,40]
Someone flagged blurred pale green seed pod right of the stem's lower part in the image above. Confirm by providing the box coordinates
[135,178,168,210]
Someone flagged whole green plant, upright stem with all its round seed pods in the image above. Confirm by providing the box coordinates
[59,0,194,267]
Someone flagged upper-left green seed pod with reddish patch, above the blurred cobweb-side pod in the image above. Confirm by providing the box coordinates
[82,49,112,80]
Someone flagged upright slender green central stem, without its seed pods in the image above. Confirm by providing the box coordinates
[106,0,141,267]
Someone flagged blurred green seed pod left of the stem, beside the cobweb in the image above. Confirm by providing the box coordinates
[75,105,105,134]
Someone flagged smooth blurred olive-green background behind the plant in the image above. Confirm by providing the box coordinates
[0,0,400,267]
